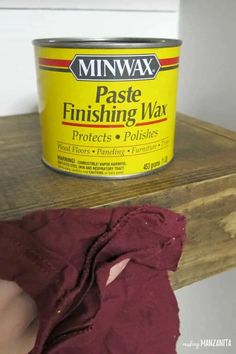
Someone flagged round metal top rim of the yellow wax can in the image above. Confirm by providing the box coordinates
[33,37,182,48]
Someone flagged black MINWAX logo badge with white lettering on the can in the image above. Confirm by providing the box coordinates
[70,54,160,81]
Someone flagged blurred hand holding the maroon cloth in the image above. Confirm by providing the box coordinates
[0,279,39,354]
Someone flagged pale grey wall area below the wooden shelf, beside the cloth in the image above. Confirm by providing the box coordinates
[175,268,236,354]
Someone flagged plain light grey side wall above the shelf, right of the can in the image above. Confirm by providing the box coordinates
[178,0,236,130]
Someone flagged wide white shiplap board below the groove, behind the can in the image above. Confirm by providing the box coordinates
[0,9,178,116]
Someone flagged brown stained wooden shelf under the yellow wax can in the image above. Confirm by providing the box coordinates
[0,114,236,289]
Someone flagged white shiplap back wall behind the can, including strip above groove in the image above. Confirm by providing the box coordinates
[0,0,179,116]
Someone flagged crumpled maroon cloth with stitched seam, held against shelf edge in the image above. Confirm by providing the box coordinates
[0,206,185,354]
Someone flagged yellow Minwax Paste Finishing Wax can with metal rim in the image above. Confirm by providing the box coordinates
[33,38,181,178]
